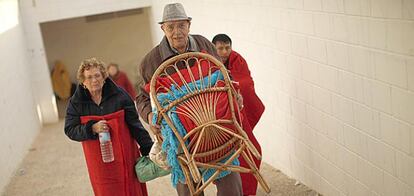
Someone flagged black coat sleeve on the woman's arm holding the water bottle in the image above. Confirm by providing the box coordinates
[65,101,98,141]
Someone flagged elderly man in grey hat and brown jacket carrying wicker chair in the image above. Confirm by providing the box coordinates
[136,3,243,196]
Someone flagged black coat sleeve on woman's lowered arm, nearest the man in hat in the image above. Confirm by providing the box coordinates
[121,89,153,156]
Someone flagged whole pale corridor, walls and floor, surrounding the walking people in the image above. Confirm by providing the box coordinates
[0,0,414,196]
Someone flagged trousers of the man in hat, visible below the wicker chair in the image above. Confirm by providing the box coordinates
[177,172,243,196]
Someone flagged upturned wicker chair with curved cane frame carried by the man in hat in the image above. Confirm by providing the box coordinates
[150,52,270,195]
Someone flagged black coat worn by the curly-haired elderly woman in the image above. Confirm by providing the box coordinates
[65,78,153,156]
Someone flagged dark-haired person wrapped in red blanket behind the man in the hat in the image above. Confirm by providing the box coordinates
[212,34,265,195]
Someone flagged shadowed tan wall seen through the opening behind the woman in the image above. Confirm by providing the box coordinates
[41,8,152,86]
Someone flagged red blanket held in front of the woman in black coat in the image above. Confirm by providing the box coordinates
[81,110,148,196]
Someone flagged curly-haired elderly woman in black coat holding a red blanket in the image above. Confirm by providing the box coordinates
[65,58,153,196]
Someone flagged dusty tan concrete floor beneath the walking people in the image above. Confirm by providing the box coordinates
[2,121,317,196]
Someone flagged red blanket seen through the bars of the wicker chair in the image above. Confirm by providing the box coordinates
[145,61,240,163]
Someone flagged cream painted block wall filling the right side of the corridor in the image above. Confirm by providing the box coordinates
[152,0,414,196]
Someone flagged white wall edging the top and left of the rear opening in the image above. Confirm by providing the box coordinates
[19,0,150,123]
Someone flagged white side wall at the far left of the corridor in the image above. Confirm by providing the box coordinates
[0,0,40,194]
